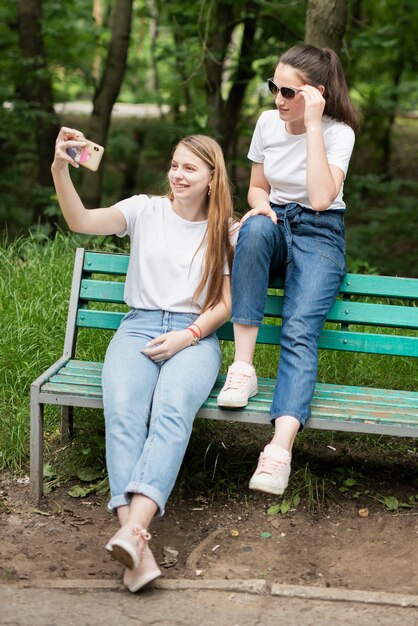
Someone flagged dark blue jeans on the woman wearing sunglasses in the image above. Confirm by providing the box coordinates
[232,203,346,427]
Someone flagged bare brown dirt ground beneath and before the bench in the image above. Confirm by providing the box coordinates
[0,448,418,594]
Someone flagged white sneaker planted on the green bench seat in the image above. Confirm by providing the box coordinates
[217,361,258,408]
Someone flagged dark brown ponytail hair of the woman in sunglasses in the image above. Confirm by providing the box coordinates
[279,44,359,132]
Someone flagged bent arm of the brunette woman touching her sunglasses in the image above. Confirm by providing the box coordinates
[300,85,344,211]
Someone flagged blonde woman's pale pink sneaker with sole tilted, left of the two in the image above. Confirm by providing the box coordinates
[106,524,151,570]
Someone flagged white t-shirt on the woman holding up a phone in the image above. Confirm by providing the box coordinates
[115,194,229,314]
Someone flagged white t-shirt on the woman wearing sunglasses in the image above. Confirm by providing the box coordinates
[248,110,355,210]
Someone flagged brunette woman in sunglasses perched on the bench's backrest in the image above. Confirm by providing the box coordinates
[218,45,358,494]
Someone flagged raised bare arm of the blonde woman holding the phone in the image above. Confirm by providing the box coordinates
[51,127,126,235]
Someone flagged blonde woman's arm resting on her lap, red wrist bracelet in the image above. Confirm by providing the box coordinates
[142,275,232,363]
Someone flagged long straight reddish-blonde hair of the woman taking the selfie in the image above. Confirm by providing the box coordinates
[168,135,235,311]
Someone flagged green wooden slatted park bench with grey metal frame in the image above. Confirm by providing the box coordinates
[30,248,418,501]
